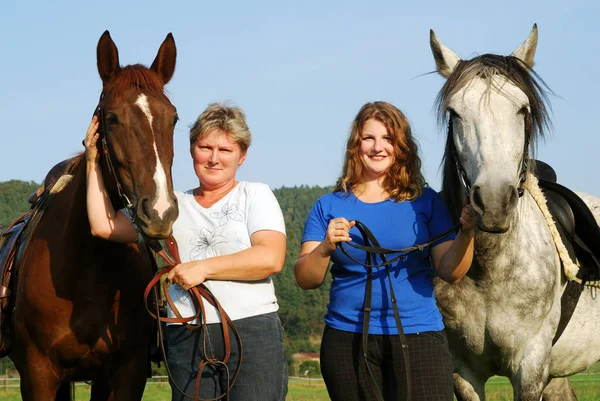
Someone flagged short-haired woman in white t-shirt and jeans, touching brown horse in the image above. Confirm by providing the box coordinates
[85,104,287,401]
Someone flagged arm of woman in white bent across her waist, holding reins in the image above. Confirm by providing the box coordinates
[167,230,286,290]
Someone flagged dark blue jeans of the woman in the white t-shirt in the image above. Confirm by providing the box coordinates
[166,312,288,401]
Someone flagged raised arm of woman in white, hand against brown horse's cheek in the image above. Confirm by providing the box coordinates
[84,116,138,243]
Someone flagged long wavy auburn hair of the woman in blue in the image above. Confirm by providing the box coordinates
[334,102,425,202]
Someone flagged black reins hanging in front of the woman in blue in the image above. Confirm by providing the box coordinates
[339,220,461,401]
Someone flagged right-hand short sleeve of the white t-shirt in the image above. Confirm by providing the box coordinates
[248,183,285,236]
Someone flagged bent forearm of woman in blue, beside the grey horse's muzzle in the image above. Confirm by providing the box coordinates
[431,201,476,283]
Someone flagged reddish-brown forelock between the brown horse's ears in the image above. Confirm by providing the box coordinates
[104,64,167,99]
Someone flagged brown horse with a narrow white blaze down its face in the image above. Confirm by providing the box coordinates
[9,31,178,401]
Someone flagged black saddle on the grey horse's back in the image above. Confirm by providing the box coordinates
[534,160,600,281]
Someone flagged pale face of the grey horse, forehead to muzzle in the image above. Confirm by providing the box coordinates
[448,75,529,231]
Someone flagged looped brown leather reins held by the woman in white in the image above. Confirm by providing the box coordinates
[144,237,242,401]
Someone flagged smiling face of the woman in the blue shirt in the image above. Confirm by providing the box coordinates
[358,118,394,180]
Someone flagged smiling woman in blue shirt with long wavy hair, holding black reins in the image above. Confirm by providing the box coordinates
[294,102,476,401]
